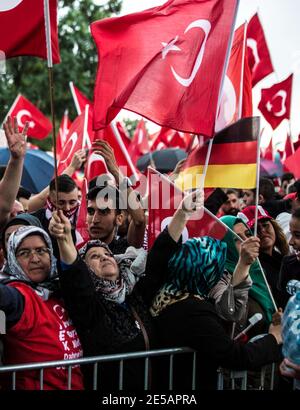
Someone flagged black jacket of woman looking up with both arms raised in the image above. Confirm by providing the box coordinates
[59,229,178,390]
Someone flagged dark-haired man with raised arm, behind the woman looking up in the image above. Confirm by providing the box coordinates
[87,141,145,254]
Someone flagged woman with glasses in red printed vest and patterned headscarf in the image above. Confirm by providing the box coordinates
[0,226,83,390]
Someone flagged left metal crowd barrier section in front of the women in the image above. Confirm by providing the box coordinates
[0,347,196,390]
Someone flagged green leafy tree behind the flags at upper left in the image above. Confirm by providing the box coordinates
[0,0,122,150]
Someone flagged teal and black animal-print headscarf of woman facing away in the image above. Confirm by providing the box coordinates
[151,236,227,316]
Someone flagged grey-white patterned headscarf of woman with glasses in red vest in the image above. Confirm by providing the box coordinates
[6,226,58,300]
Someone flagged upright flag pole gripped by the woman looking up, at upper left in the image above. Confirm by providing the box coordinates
[44,0,58,207]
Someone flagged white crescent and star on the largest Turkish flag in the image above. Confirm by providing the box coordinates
[161,19,211,87]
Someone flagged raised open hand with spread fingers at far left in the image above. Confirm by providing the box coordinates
[3,116,29,159]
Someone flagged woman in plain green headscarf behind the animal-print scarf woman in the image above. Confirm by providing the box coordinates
[220,216,275,334]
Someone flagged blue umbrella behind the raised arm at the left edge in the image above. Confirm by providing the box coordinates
[0,148,54,194]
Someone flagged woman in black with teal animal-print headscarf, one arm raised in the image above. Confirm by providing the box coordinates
[148,193,282,390]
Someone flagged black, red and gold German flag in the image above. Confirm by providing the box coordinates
[176,117,260,190]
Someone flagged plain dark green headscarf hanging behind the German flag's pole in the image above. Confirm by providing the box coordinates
[220,215,275,323]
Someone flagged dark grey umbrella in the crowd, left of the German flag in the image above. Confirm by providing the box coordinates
[137,148,187,172]
